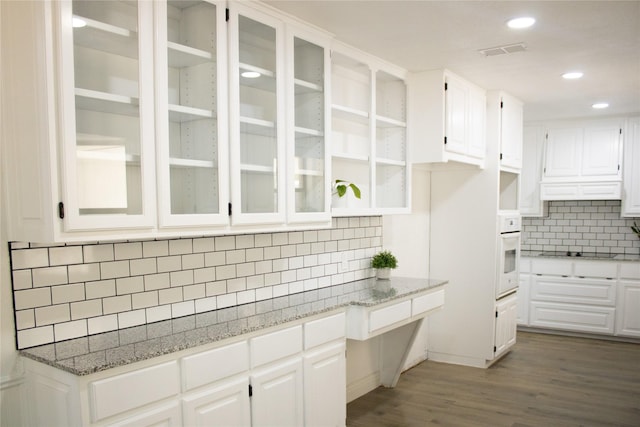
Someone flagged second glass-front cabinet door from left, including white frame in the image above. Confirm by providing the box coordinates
[155,0,229,227]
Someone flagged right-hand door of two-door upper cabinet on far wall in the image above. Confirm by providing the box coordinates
[581,121,622,178]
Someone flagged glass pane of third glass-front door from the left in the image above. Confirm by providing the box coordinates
[237,16,280,213]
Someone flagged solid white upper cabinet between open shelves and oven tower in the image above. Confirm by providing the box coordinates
[408,70,487,167]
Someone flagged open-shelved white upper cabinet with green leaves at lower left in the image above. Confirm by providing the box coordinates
[331,43,411,216]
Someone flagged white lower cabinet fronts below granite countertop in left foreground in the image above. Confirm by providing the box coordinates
[24,312,347,427]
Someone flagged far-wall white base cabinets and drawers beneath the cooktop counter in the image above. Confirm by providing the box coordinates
[518,253,640,338]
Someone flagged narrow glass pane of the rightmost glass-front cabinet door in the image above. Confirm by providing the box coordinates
[294,37,326,212]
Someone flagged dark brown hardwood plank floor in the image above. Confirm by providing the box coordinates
[347,332,640,427]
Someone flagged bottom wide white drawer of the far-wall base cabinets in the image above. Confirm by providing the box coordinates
[530,302,615,334]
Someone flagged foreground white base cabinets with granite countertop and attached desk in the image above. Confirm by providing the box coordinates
[22,278,446,426]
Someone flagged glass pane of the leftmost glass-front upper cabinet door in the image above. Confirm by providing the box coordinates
[73,1,142,215]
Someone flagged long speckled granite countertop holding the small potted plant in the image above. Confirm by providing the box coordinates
[20,277,447,375]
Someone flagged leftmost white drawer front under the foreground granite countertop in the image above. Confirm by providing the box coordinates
[89,361,180,421]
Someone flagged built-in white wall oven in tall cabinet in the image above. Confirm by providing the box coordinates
[496,212,521,299]
